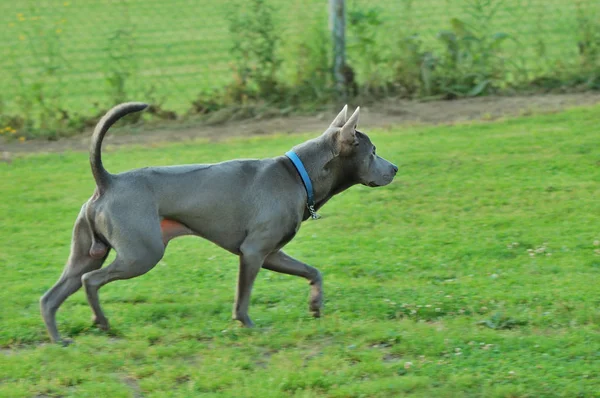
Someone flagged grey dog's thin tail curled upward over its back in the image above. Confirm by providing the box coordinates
[90,102,148,194]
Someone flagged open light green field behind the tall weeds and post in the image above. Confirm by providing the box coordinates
[0,0,600,117]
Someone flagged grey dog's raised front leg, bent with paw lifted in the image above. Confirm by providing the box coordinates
[263,250,323,318]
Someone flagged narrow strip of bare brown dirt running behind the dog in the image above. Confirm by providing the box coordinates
[0,92,600,155]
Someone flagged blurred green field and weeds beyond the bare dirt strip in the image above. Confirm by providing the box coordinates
[0,0,600,139]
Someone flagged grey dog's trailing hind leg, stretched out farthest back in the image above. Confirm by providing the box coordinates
[40,205,109,345]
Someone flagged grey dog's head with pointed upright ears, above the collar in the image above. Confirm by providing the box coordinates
[326,105,398,187]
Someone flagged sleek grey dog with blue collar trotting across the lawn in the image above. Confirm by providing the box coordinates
[40,102,398,344]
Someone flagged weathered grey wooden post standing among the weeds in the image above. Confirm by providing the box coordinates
[329,0,348,103]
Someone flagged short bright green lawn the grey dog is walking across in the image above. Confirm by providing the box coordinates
[0,107,600,397]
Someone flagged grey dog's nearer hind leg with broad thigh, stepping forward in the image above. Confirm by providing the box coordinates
[81,215,165,330]
